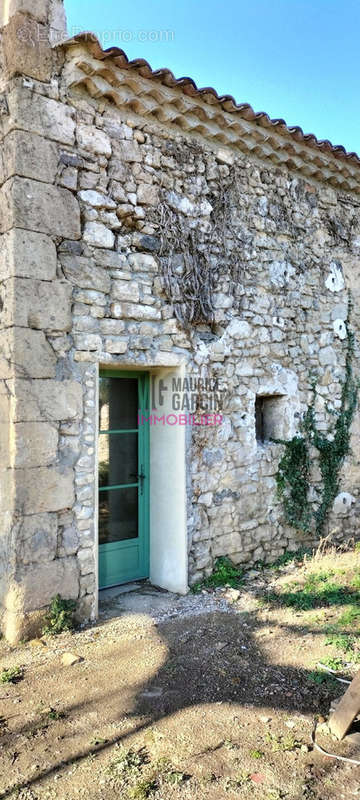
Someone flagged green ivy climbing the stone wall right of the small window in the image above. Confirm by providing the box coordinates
[276,293,359,536]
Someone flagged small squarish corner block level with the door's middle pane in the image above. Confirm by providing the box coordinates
[13,422,58,468]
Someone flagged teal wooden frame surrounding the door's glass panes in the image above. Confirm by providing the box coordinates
[96,367,150,589]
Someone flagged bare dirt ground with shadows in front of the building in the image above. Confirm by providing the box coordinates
[0,554,360,800]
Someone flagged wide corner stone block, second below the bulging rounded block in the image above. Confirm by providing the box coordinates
[0,278,72,331]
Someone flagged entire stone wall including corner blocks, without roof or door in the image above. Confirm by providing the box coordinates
[0,3,360,638]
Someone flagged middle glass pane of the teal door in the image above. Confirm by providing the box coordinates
[99,433,138,487]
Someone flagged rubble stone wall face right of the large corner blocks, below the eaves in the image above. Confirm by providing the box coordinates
[54,76,360,582]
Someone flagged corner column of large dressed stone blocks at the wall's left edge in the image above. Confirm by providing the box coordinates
[0,2,82,641]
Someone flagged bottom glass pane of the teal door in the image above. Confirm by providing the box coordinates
[99,488,138,544]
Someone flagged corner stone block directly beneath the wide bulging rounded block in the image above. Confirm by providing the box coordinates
[0,228,56,281]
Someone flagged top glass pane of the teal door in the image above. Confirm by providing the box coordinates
[99,378,138,431]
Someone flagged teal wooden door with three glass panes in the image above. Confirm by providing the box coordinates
[98,370,149,589]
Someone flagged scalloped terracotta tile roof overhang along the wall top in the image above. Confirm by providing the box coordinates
[59,33,360,193]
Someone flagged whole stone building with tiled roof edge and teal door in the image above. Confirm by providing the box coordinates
[0,0,360,641]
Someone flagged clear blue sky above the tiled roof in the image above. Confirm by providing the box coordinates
[65,0,360,153]
